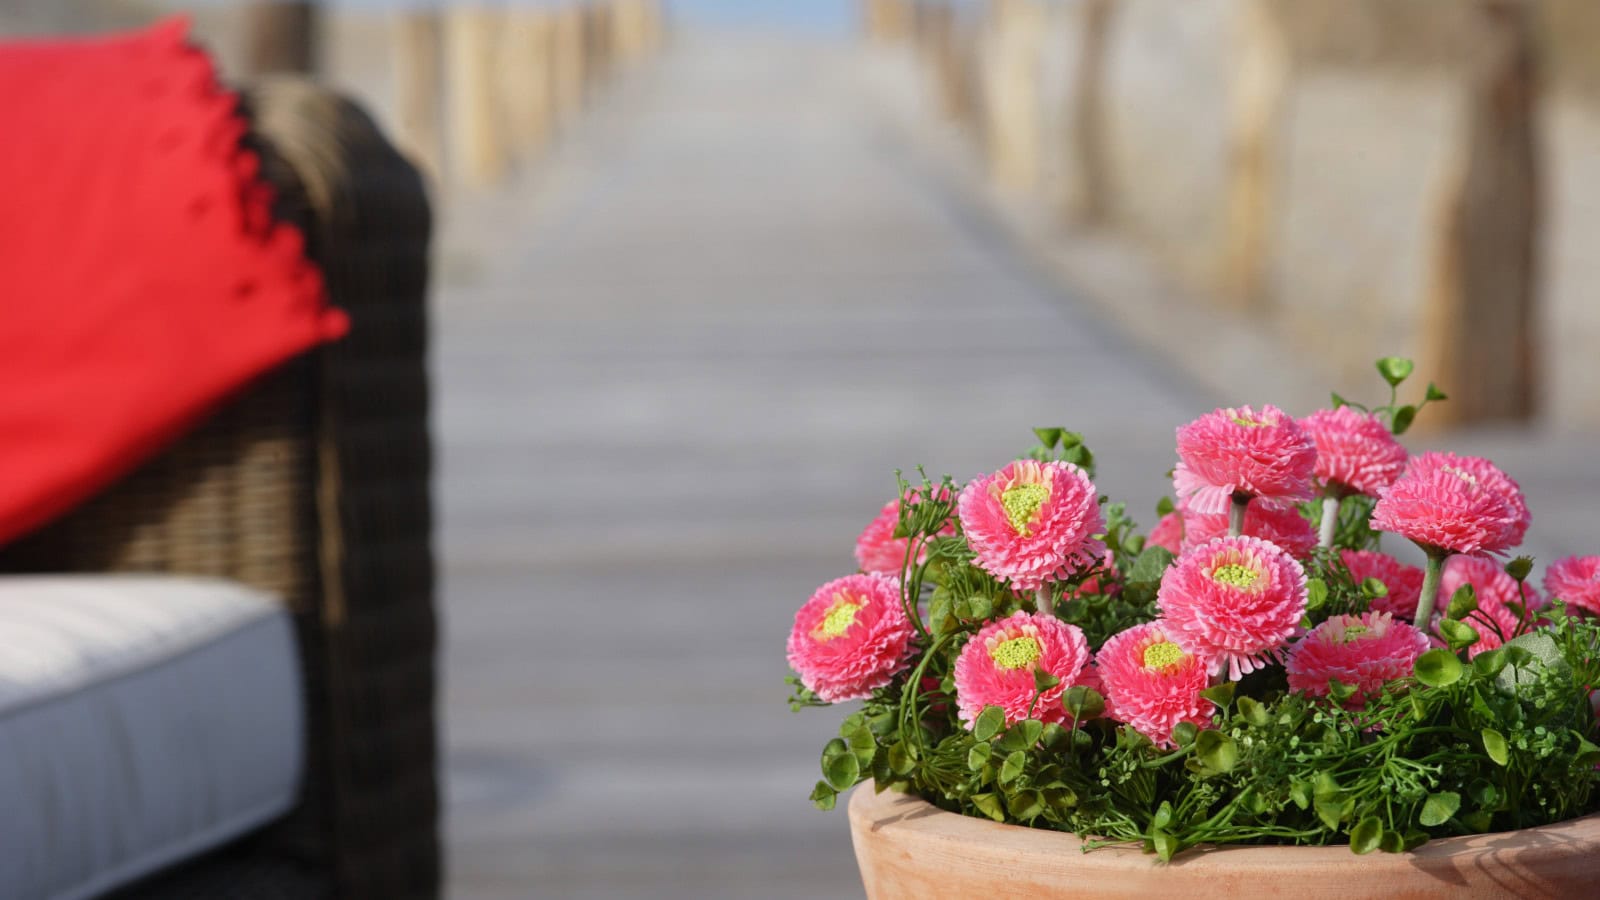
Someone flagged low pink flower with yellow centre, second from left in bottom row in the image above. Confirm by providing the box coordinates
[955,612,1090,727]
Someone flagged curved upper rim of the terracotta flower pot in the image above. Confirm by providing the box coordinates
[850,781,1600,874]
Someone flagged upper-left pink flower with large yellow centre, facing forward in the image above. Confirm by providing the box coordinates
[955,460,1106,591]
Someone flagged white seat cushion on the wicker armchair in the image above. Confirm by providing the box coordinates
[0,575,304,900]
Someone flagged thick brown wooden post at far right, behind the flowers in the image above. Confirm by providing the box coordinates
[1421,0,1541,426]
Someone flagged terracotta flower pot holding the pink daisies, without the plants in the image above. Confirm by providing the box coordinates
[850,783,1600,900]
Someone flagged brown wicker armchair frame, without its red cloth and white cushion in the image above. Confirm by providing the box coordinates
[0,80,440,900]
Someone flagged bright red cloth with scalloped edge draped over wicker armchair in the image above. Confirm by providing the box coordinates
[0,19,349,543]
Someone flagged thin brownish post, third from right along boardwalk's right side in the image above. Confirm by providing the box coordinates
[1069,0,1117,226]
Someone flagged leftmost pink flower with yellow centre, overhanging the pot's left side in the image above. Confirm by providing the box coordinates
[789,575,912,703]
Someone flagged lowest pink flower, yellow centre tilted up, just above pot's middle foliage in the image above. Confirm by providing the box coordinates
[1094,620,1213,746]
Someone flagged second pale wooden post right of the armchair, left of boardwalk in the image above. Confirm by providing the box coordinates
[445,5,506,187]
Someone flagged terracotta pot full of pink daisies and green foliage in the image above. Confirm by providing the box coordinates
[787,357,1600,898]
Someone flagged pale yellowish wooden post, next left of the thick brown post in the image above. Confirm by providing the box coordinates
[1219,0,1290,309]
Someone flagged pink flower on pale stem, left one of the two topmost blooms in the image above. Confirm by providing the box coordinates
[1173,405,1317,514]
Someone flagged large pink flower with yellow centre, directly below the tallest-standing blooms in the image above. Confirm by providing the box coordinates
[1155,536,1306,681]
